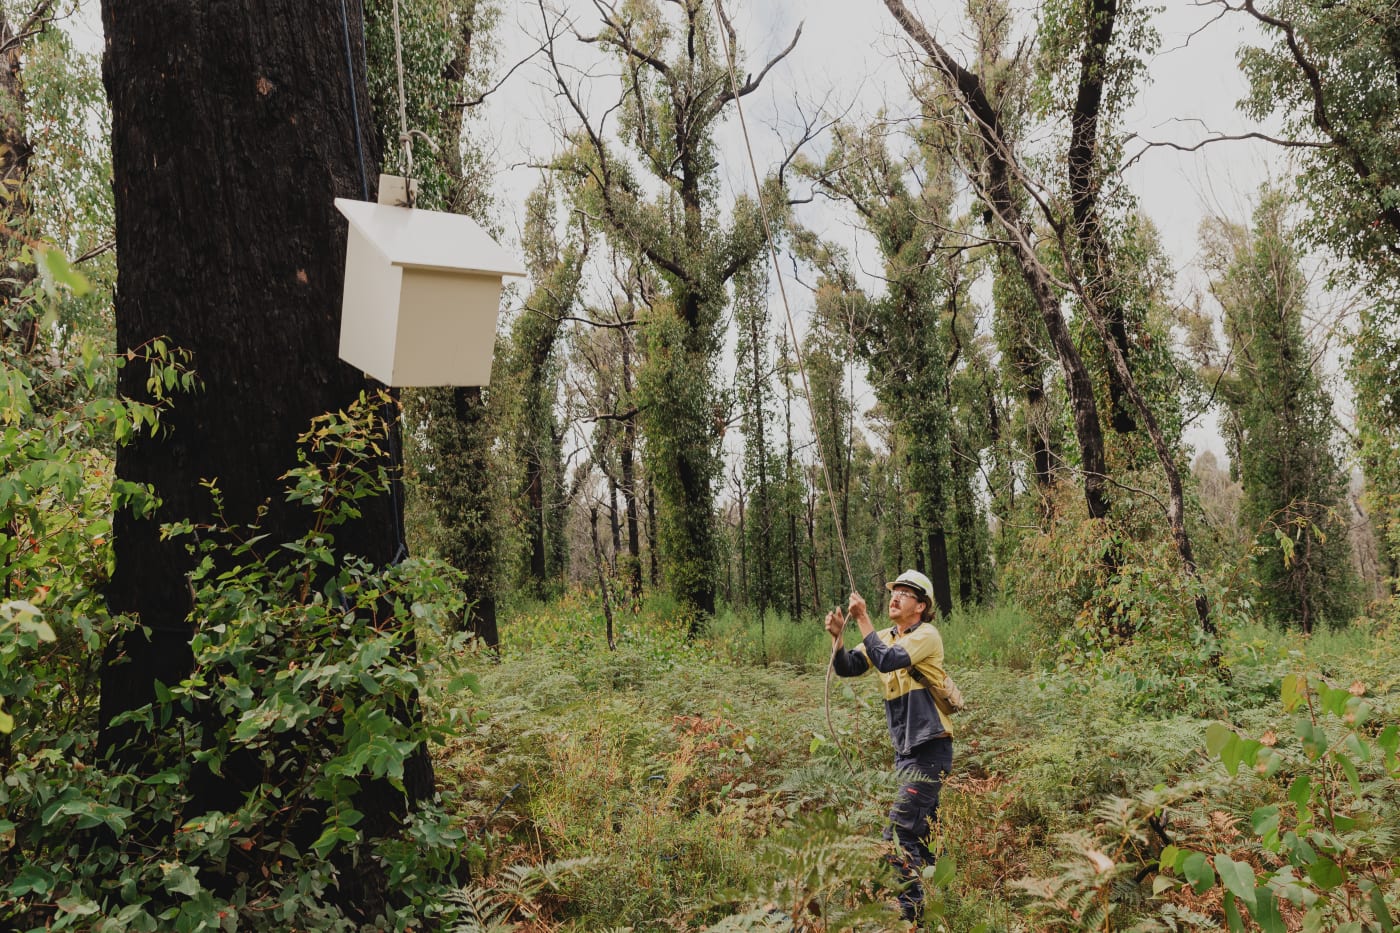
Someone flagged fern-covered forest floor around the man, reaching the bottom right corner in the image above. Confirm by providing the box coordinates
[435,594,1400,932]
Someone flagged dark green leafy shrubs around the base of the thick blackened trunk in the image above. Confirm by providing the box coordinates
[0,383,478,930]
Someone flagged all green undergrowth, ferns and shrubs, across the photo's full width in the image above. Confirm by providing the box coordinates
[0,318,1400,933]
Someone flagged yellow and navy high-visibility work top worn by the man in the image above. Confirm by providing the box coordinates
[832,622,952,755]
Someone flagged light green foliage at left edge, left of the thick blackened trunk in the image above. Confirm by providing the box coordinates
[0,256,172,750]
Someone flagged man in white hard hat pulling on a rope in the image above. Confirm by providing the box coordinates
[826,570,953,922]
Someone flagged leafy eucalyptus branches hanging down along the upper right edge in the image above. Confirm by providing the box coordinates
[1239,0,1400,602]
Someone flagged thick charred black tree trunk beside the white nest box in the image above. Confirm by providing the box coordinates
[101,0,433,909]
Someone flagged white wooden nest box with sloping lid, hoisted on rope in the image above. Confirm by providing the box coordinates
[336,175,525,385]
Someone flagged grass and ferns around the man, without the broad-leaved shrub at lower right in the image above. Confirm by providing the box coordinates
[438,593,1397,932]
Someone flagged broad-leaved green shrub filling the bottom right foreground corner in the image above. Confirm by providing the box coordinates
[1155,674,1400,932]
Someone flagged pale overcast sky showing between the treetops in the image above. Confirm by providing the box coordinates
[486,0,1275,257]
